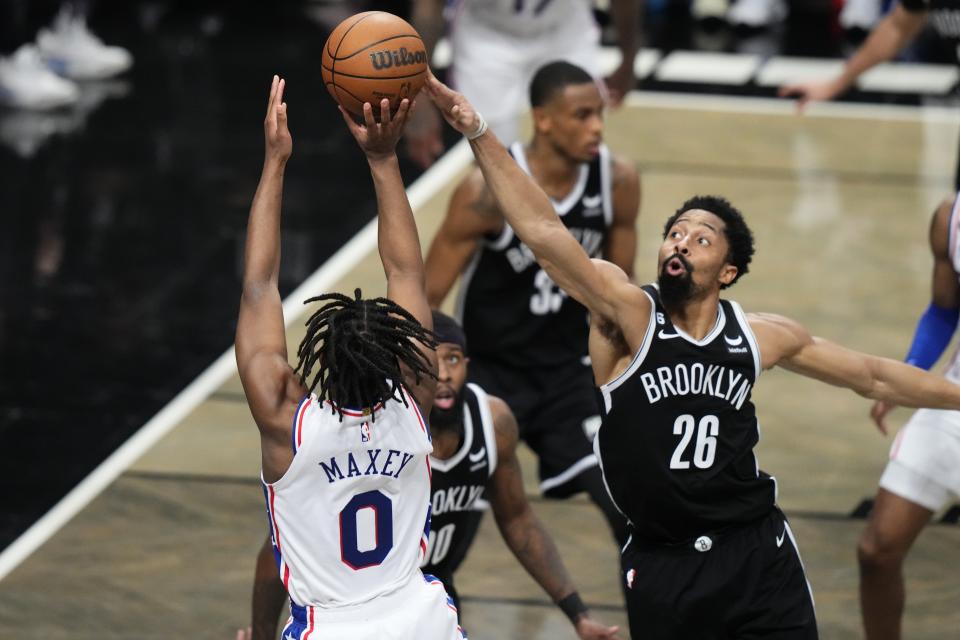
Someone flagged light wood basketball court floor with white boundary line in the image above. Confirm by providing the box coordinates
[0,93,960,640]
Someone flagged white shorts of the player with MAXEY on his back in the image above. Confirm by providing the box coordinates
[280,571,467,640]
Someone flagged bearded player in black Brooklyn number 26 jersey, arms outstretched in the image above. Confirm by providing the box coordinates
[425,76,960,640]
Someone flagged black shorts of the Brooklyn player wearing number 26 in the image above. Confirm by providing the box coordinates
[621,509,818,640]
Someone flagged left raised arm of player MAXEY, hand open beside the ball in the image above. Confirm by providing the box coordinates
[236,76,299,431]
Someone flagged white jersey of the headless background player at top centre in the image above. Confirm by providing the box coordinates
[454,0,594,37]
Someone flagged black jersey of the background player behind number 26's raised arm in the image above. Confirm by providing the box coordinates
[457,143,613,368]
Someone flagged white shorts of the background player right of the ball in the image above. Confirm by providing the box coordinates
[451,3,600,147]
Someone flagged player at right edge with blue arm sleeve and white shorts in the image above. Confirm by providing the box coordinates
[857,192,960,640]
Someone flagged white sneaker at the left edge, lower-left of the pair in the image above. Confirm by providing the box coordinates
[0,44,80,110]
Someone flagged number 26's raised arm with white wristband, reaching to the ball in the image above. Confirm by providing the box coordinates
[424,75,643,328]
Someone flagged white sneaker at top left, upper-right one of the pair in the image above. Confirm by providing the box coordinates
[37,9,133,80]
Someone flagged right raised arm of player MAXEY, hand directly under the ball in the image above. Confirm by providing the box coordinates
[339,98,437,413]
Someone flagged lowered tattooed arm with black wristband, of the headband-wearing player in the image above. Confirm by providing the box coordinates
[488,397,618,640]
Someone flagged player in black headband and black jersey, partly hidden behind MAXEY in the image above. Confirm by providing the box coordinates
[248,311,618,640]
